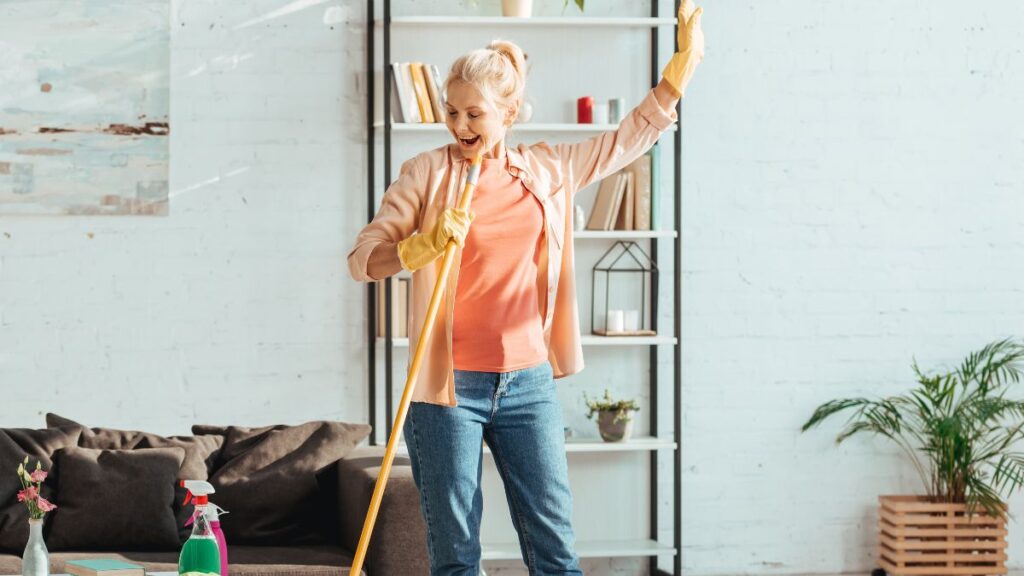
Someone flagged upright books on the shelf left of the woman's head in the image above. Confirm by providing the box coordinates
[391,61,445,124]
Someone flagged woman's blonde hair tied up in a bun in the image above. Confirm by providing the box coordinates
[444,40,526,120]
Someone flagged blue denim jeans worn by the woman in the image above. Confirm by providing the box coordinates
[402,362,583,576]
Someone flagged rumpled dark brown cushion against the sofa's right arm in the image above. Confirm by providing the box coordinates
[192,421,371,544]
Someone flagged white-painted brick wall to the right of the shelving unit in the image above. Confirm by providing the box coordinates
[683,1,1024,574]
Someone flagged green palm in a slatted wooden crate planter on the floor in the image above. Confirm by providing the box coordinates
[802,339,1024,576]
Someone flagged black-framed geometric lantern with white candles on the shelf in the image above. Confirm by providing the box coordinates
[590,240,657,336]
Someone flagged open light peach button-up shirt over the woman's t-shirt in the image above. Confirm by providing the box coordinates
[348,87,676,406]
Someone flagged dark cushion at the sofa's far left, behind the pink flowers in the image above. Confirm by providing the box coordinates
[0,428,81,553]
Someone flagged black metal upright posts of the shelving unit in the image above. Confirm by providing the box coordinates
[365,0,682,576]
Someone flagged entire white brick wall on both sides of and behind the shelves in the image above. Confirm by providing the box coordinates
[0,0,1024,575]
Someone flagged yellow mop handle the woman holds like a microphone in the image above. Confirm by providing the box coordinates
[348,156,483,576]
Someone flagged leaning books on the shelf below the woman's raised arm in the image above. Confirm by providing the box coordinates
[587,146,658,231]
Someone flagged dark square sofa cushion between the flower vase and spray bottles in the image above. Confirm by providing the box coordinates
[47,447,185,550]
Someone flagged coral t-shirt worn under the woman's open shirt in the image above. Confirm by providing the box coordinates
[452,156,548,372]
